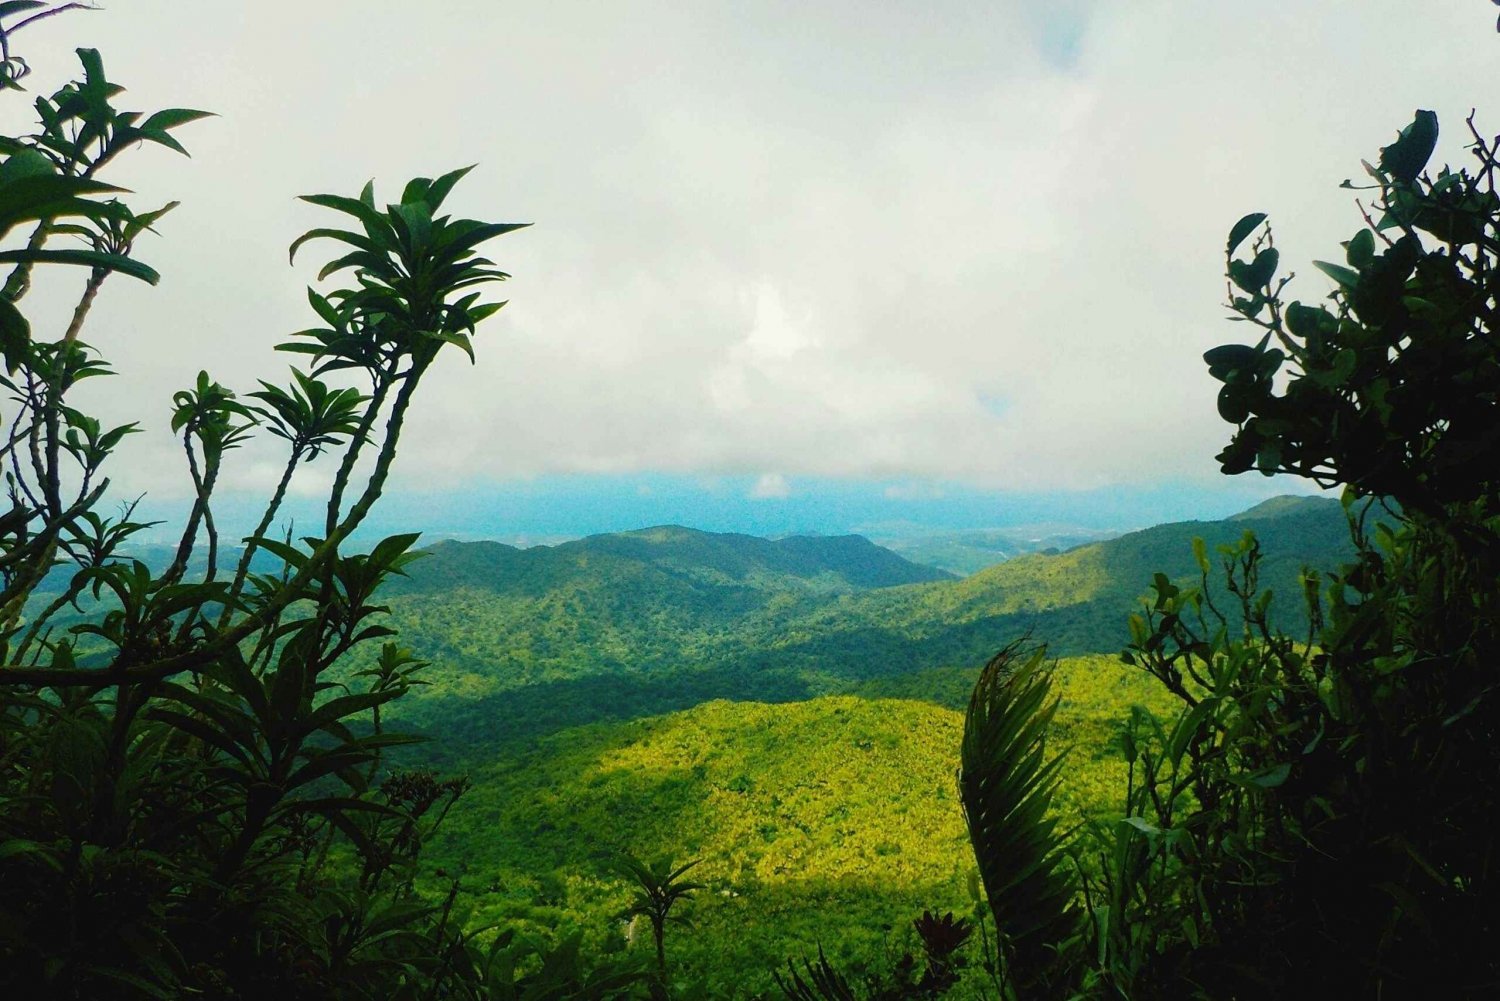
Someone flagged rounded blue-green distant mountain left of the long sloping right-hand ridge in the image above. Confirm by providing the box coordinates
[375,527,951,687]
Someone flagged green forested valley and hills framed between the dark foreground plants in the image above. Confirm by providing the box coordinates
[369,498,1349,996]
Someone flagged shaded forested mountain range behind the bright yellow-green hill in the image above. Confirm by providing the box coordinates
[375,498,1350,753]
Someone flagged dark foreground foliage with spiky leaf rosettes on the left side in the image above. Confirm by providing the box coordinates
[0,11,546,998]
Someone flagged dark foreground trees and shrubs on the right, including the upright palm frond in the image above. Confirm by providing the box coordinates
[965,111,1500,998]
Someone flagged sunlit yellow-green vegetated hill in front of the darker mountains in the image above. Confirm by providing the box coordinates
[428,657,1160,995]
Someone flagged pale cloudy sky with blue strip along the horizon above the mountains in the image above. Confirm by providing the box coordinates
[0,0,1500,537]
